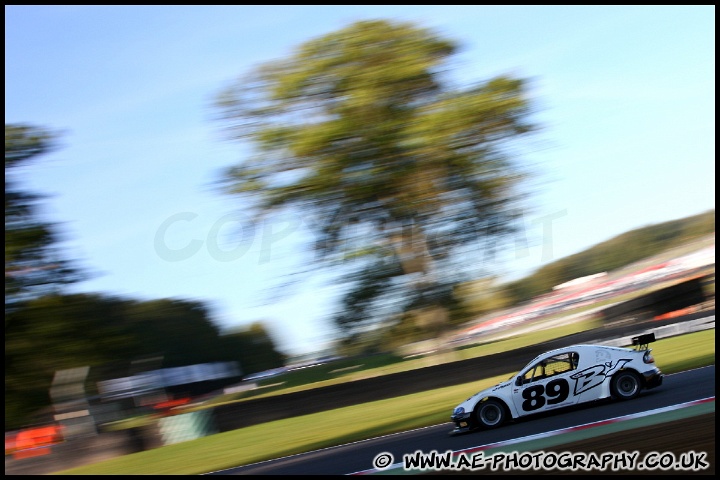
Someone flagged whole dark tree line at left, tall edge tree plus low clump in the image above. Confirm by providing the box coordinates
[5,125,285,430]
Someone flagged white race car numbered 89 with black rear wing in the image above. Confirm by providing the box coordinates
[450,333,663,433]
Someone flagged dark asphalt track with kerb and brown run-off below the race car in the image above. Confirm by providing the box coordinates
[211,365,715,475]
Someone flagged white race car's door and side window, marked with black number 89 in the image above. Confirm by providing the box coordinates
[513,352,578,415]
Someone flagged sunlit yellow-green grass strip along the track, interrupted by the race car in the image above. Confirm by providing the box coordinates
[58,329,715,475]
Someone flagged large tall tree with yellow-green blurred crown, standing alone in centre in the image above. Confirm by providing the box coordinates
[217,20,535,342]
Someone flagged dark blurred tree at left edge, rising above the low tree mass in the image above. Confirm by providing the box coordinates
[5,124,80,316]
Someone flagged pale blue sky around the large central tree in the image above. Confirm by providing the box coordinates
[5,5,715,354]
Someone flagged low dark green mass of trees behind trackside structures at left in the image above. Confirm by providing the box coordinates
[5,294,284,429]
